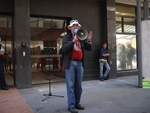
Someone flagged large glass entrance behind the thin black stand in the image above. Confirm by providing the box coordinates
[30,17,66,84]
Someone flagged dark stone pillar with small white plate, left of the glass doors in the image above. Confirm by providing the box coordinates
[13,0,31,88]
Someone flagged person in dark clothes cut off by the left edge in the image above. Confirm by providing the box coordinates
[0,44,8,90]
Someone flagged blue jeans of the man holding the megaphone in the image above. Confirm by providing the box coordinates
[65,60,84,108]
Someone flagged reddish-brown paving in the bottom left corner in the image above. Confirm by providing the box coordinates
[0,87,34,113]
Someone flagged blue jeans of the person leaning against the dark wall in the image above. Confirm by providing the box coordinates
[99,62,110,77]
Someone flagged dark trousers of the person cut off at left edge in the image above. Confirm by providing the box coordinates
[0,61,6,88]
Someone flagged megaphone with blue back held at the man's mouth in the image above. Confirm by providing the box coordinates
[74,28,88,40]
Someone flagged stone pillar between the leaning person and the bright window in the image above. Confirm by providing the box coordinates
[106,0,117,78]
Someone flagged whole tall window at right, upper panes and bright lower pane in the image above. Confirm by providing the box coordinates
[116,4,137,70]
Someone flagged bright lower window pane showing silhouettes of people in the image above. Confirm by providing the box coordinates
[116,34,137,70]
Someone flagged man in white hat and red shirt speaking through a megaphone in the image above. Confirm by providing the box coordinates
[62,20,93,113]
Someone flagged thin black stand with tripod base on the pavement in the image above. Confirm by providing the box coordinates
[42,44,64,102]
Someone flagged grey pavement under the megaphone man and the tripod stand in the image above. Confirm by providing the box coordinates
[19,76,150,113]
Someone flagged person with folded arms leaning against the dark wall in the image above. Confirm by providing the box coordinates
[99,42,110,81]
